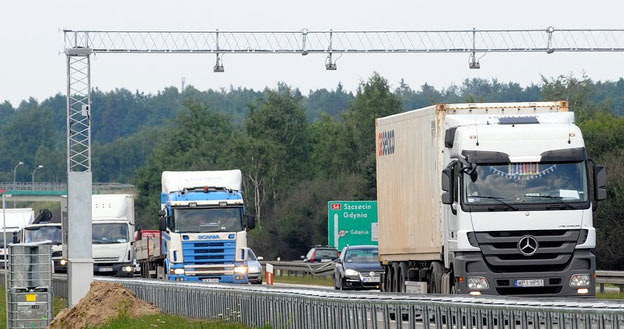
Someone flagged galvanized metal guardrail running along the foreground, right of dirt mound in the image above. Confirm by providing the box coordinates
[47,275,624,329]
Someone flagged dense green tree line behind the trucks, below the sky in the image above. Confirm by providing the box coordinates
[0,74,624,269]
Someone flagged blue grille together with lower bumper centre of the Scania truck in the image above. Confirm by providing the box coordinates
[182,240,236,276]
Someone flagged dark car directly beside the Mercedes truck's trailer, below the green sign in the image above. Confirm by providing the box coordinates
[334,246,383,290]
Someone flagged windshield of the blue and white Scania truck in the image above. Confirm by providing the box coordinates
[173,207,243,233]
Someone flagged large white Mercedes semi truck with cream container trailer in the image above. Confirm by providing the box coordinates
[376,101,606,296]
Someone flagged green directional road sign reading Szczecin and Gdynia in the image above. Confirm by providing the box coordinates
[327,201,378,250]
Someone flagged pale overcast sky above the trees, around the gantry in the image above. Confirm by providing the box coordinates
[0,0,624,105]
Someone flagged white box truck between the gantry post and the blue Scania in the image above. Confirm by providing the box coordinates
[91,194,134,276]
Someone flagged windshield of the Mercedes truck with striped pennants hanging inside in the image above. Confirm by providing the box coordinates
[463,162,588,205]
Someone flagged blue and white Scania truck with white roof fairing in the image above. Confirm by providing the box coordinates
[136,170,255,283]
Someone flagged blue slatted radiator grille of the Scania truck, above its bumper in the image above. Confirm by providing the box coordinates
[182,240,236,265]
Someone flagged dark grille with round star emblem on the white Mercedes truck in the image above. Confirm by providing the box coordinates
[475,230,581,273]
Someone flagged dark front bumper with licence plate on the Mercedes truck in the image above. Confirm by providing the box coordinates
[454,250,596,297]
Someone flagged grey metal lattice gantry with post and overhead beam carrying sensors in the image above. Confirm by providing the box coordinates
[64,27,624,304]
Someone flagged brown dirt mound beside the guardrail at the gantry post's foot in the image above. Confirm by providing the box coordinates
[48,281,160,329]
